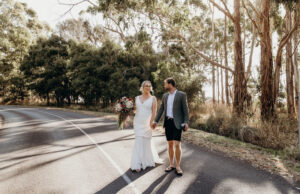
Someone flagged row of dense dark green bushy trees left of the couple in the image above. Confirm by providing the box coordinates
[20,35,159,106]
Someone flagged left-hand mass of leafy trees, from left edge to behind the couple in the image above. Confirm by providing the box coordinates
[0,0,206,107]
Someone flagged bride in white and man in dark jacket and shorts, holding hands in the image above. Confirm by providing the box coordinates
[131,78,189,176]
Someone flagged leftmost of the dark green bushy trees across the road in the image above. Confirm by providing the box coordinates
[20,35,69,105]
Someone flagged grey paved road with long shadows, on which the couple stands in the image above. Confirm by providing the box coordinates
[0,106,299,194]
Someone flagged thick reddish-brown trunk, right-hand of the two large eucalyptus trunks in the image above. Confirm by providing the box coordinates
[260,0,274,120]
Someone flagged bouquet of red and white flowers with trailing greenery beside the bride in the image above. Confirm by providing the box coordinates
[115,96,134,129]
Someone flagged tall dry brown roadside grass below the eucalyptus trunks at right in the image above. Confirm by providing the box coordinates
[190,101,298,150]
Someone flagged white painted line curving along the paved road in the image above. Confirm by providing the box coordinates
[38,110,141,194]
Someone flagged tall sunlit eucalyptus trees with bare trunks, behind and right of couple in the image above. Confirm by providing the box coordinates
[69,0,300,121]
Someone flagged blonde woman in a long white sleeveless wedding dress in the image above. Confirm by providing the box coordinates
[131,81,163,172]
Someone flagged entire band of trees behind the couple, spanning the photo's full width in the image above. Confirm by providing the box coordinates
[0,0,300,121]
